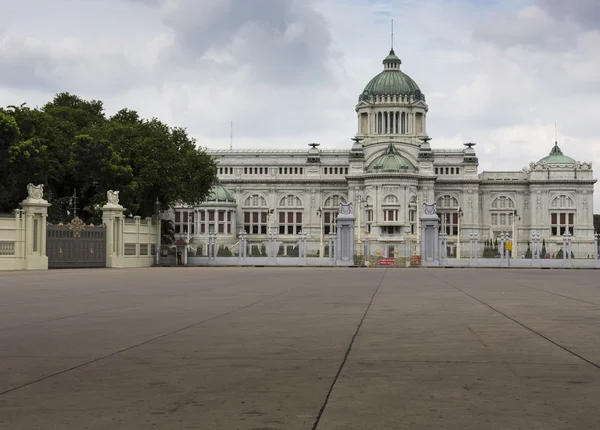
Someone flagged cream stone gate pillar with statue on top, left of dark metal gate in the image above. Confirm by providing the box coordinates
[21,184,50,270]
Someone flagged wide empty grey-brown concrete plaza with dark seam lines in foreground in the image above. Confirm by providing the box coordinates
[0,268,600,430]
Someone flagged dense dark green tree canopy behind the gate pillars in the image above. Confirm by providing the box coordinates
[0,93,216,222]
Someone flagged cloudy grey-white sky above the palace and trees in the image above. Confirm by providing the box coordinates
[0,0,600,208]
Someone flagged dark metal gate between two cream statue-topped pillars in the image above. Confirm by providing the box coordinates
[46,218,106,269]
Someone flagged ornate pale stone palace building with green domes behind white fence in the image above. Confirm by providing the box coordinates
[169,49,595,258]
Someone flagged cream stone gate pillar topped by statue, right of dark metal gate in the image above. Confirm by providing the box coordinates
[102,190,125,267]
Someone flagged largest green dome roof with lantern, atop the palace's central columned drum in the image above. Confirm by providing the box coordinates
[359,49,425,100]
